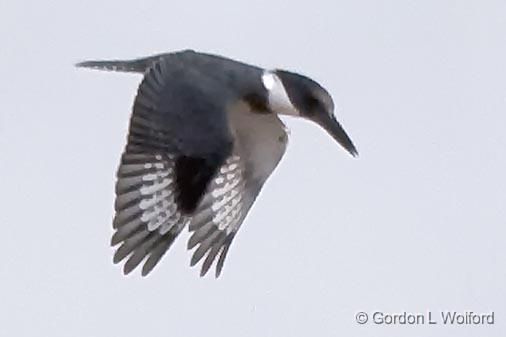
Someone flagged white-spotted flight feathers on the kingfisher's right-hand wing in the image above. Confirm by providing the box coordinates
[188,155,255,277]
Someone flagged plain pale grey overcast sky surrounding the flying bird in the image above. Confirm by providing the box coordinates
[0,0,506,337]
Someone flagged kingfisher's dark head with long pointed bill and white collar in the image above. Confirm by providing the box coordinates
[262,70,358,156]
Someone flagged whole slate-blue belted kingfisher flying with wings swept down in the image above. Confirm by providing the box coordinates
[76,50,357,277]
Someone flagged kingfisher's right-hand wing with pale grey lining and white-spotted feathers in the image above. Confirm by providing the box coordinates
[188,102,287,277]
